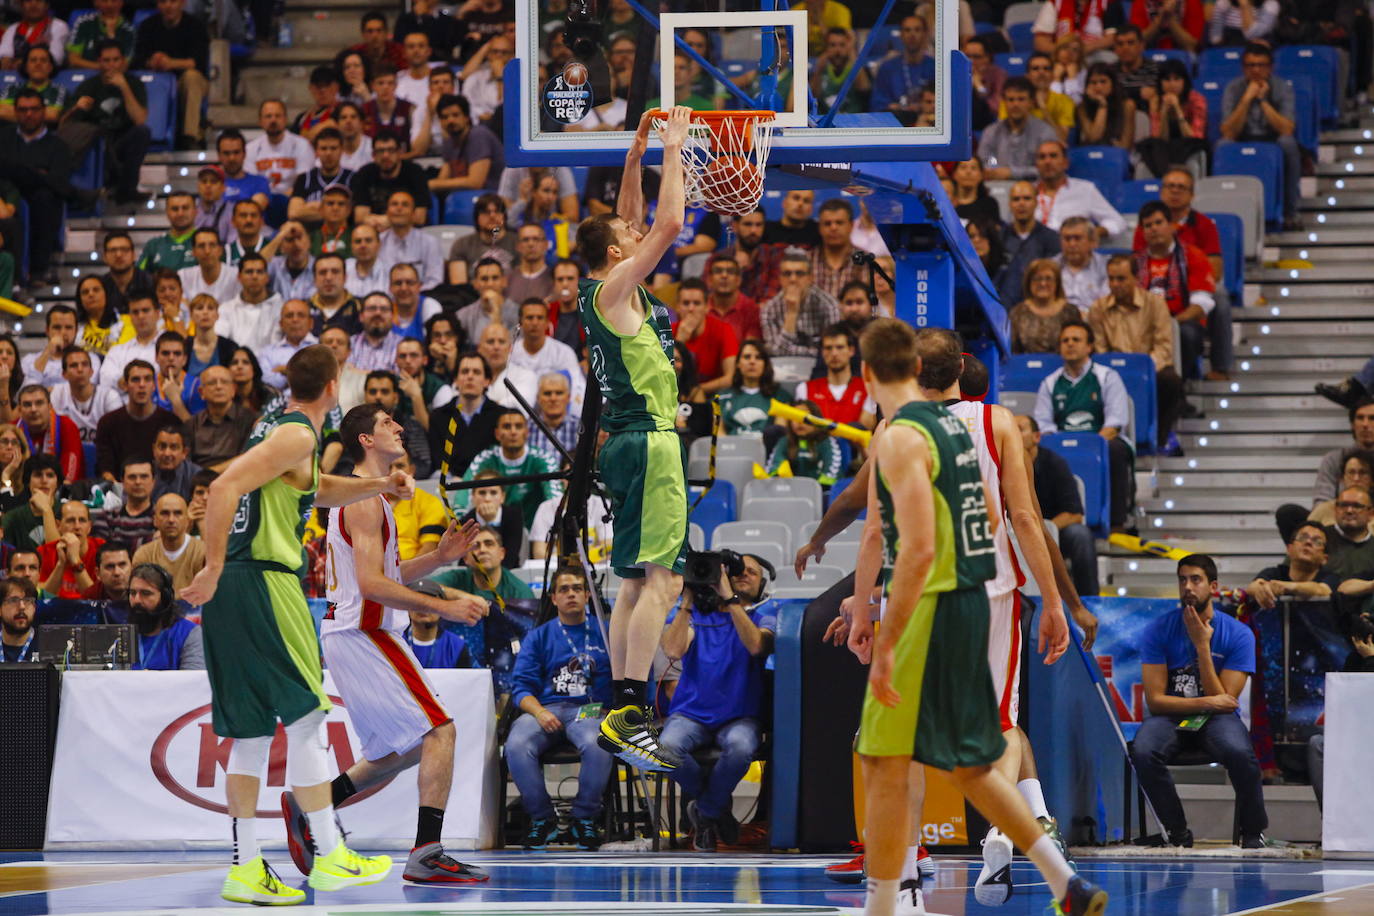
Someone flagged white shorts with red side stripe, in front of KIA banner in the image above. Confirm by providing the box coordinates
[320,629,452,761]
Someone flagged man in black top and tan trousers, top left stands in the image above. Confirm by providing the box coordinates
[133,0,210,150]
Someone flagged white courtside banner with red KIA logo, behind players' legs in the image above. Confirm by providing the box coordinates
[47,669,500,849]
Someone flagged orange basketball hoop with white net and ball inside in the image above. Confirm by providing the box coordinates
[650,110,776,216]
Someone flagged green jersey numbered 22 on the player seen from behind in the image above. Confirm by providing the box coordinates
[878,401,998,593]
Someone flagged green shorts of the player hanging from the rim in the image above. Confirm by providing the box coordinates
[598,430,687,578]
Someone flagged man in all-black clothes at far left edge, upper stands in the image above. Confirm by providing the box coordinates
[0,86,85,287]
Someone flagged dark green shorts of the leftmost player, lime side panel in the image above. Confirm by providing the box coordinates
[201,563,330,737]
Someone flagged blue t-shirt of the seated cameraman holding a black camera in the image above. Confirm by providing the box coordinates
[669,602,778,728]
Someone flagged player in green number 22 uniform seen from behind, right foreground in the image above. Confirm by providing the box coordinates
[856,319,1106,916]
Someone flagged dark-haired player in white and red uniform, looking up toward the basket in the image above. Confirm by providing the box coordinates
[282,404,488,884]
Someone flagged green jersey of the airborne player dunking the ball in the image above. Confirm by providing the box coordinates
[577,280,677,433]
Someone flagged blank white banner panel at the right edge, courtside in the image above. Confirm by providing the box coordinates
[1322,673,1374,858]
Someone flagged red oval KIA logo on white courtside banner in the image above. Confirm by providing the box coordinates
[148,696,394,818]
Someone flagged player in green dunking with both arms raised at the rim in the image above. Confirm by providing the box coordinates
[577,106,690,770]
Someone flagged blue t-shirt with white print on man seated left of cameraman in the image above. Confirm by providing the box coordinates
[511,617,611,706]
